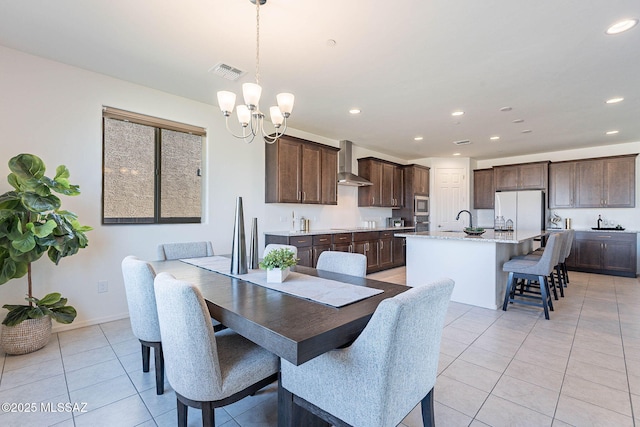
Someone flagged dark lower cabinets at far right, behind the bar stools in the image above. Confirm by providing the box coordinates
[567,231,637,277]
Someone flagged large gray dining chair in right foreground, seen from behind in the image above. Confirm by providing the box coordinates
[279,279,454,427]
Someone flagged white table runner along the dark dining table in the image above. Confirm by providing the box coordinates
[180,256,384,307]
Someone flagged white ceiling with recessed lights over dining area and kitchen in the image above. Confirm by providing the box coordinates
[0,0,640,160]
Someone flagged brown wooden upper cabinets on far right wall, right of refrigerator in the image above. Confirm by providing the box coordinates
[549,154,637,208]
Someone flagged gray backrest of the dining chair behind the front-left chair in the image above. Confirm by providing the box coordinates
[122,256,160,342]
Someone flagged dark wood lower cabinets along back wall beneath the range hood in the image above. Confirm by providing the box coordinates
[265,230,405,273]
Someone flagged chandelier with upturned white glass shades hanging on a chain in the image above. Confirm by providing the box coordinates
[218,0,294,144]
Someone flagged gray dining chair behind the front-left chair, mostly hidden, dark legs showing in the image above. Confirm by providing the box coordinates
[122,256,164,394]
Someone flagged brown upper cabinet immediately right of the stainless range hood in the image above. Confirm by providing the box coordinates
[358,157,404,208]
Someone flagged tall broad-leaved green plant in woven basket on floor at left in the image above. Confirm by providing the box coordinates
[0,154,91,354]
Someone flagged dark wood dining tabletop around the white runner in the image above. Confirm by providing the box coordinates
[151,261,409,365]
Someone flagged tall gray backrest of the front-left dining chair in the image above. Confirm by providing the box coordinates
[155,273,222,402]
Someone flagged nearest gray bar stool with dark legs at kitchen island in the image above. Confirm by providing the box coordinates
[502,234,562,320]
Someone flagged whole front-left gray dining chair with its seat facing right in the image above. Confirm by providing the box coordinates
[155,273,278,427]
